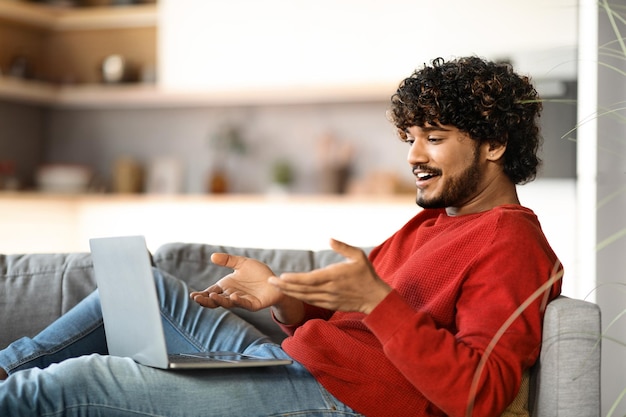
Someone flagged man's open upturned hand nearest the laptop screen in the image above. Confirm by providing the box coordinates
[190,253,284,311]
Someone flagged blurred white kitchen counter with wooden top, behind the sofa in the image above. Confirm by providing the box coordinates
[0,192,419,253]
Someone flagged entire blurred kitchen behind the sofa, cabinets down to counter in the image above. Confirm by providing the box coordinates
[0,0,576,274]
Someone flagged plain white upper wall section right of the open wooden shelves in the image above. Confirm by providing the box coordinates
[159,0,577,90]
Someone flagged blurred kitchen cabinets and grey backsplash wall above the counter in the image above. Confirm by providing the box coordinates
[0,0,577,194]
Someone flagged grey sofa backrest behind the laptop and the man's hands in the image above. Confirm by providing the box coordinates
[0,243,340,349]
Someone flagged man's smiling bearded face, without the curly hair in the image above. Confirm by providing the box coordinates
[407,125,483,211]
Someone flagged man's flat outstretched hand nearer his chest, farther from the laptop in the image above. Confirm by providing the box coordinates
[269,239,391,314]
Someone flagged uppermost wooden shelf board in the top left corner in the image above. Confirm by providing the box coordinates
[0,0,158,31]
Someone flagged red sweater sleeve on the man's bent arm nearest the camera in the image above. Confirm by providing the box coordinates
[364,211,560,416]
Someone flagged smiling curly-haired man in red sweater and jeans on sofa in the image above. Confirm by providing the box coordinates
[0,57,561,416]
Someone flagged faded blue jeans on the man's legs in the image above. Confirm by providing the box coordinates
[0,270,358,417]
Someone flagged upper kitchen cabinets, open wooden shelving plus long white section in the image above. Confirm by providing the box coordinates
[0,0,577,108]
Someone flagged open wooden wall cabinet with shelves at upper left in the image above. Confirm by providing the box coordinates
[0,0,158,105]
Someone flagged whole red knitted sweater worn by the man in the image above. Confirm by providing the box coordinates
[283,205,560,417]
